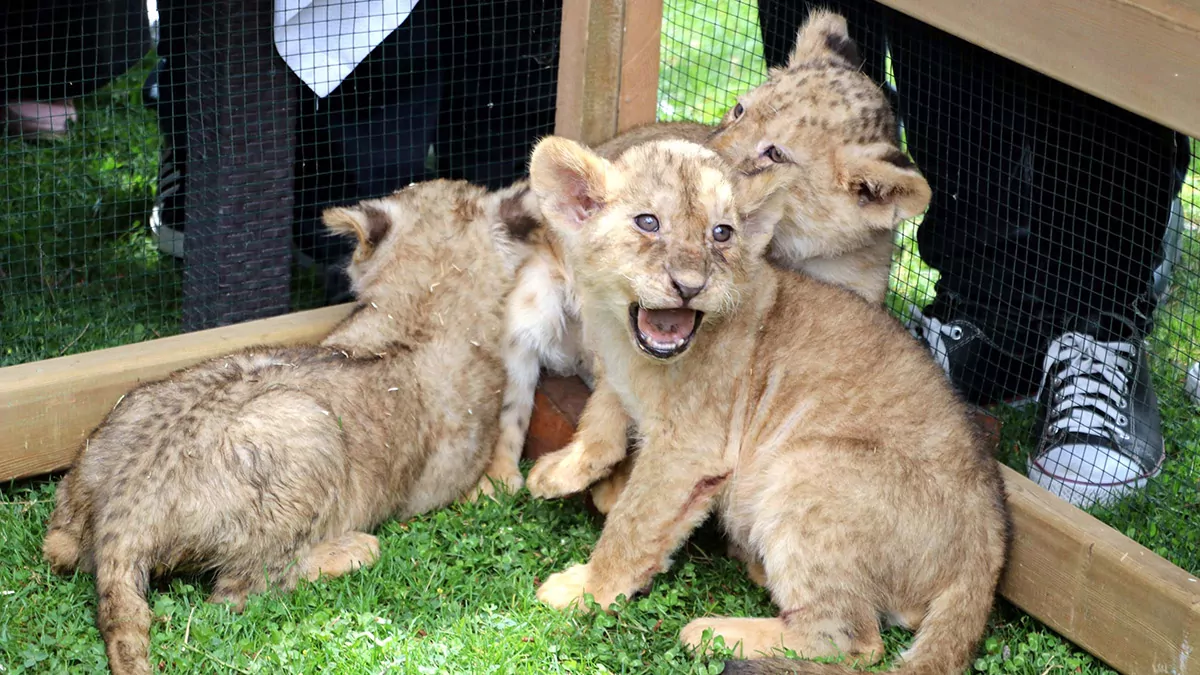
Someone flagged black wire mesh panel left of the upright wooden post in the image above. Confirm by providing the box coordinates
[0,0,562,357]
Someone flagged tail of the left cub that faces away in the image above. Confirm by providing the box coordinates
[96,533,150,675]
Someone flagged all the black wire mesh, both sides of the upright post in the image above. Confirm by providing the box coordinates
[0,0,1200,572]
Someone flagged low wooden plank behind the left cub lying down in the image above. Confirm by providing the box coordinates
[0,304,353,482]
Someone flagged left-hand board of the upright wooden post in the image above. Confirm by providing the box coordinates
[554,0,625,144]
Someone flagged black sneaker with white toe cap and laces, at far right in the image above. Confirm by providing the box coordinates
[1028,321,1165,508]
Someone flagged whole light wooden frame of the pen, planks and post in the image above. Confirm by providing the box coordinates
[0,0,1200,675]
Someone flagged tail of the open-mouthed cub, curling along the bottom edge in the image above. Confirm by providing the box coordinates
[724,577,994,675]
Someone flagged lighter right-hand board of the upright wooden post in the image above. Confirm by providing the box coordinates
[617,0,662,133]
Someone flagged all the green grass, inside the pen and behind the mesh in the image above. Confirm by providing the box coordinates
[0,1,1200,675]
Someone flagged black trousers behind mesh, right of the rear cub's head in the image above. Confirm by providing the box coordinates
[758,0,1189,389]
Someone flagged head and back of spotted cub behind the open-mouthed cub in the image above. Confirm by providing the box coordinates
[596,10,931,304]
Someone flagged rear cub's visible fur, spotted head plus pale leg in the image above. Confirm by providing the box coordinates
[488,12,930,501]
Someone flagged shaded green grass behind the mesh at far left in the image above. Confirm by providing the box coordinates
[0,54,320,366]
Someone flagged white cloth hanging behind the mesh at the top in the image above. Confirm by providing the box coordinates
[275,0,418,98]
